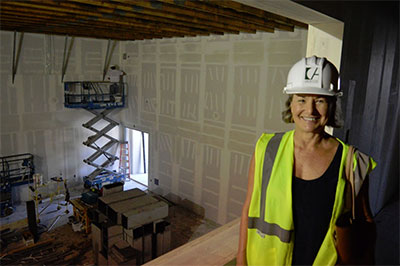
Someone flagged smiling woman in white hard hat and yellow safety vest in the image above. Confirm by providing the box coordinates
[237,56,375,265]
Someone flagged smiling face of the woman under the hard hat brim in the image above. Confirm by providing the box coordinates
[290,94,328,133]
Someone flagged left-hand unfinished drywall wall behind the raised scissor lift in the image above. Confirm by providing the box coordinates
[0,31,118,197]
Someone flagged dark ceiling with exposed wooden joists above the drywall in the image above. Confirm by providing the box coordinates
[0,0,307,40]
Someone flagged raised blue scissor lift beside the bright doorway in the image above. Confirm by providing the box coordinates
[64,81,125,189]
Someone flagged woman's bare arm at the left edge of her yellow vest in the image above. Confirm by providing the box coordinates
[236,154,254,265]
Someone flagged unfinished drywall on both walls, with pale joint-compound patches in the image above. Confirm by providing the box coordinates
[0,29,307,223]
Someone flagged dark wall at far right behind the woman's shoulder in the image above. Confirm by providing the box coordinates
[296,1,400,265]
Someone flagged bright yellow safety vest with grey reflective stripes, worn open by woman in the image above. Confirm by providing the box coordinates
[246,131,376,265]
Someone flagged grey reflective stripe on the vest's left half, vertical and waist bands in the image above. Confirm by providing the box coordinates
[248,133,292,243]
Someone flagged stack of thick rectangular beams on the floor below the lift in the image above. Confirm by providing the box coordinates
[91,188,171,265]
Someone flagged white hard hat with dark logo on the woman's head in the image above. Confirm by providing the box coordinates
[283,56,342,96]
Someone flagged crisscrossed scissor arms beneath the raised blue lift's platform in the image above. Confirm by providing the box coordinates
[82,109,120,185]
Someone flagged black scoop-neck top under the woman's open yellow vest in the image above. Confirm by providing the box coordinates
[292,144,343,265]
